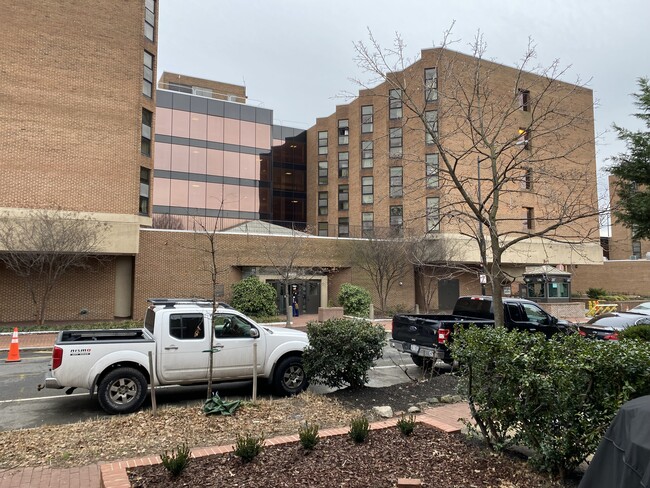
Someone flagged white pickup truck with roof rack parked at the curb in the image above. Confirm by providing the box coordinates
[45,299,308,413]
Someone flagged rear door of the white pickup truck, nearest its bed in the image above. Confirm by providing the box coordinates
[158,313,209,383]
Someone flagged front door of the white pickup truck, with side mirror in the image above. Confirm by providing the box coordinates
[213,311,266,380]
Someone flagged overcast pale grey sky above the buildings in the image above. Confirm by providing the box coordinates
[158,0,650,201]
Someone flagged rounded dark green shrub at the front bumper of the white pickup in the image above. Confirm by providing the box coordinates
[302,319,386,388]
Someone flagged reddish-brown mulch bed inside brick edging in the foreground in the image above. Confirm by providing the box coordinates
[129,424,562,488]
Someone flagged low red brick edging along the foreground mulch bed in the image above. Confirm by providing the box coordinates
[99,412,461,488]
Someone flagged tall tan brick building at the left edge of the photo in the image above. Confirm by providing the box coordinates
[0,0,158,320]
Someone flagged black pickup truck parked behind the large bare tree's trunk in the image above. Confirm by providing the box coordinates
[390,296,573,366]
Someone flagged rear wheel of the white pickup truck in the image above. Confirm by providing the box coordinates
[97,367,147,414]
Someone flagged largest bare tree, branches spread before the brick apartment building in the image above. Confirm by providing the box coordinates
[355,34,599,323]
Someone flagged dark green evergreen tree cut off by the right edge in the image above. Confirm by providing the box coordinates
[609,78,650,239]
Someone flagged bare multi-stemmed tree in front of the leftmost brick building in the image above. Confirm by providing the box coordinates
[0,210,106,324]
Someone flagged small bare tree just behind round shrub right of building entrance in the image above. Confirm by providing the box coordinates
[352,228,412,312]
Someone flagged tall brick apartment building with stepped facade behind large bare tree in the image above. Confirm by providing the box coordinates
[307,49,602,302]
